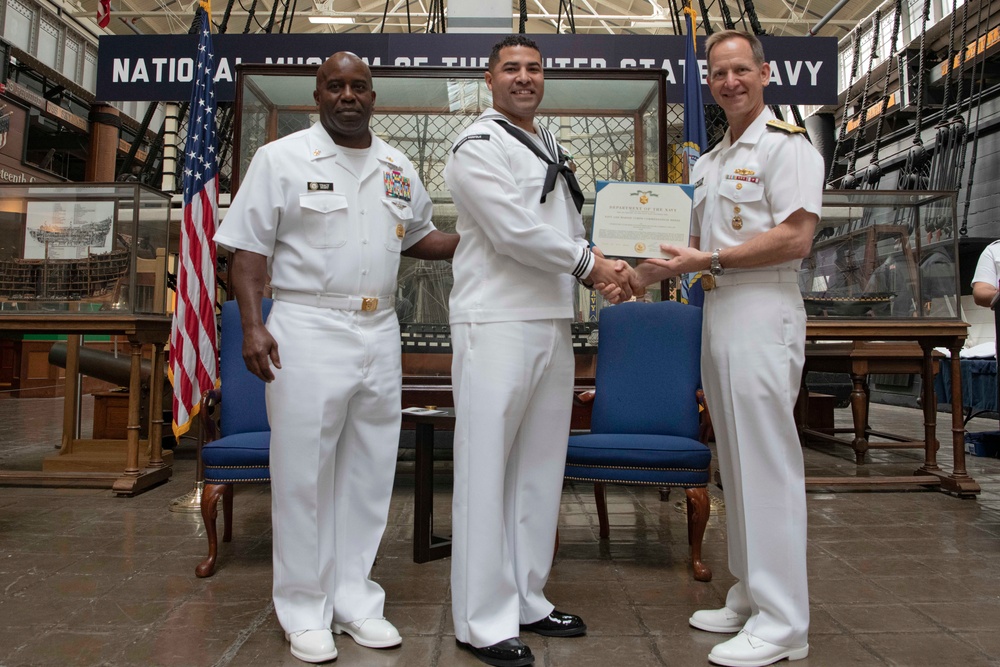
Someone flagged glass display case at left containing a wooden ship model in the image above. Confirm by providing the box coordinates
[0,183,170,317]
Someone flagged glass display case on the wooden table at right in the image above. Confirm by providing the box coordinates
[799,190,961,320]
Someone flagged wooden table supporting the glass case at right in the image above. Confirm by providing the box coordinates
[802,319,980,497]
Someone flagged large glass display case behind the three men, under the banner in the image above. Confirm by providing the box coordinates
[233,65,683,324]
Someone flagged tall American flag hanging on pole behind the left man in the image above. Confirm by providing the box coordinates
[170,8,219,444]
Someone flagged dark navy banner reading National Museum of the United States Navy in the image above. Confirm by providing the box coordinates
[97,33,837,105]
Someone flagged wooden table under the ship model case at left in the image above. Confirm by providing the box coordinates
[0,311,173,496]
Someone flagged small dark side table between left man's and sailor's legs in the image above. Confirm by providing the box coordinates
[403,408,455,563]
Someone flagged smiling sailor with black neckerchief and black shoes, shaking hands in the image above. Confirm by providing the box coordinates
[444,35,630,667]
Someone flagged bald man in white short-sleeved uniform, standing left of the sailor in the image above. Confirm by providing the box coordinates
[215,53,458,662]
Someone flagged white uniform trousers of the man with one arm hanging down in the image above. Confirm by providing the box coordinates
[266,301,401,632]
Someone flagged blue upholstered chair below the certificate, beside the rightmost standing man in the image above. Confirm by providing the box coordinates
[566,301,712,581]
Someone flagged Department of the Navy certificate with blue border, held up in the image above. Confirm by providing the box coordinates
[592,181,694,257]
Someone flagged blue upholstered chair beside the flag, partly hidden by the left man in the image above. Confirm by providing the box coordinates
[195,299,271,577]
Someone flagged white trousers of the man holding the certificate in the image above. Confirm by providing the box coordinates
[702,283,809,647]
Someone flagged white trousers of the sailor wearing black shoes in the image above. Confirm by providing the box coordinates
[451,320,574,647]
